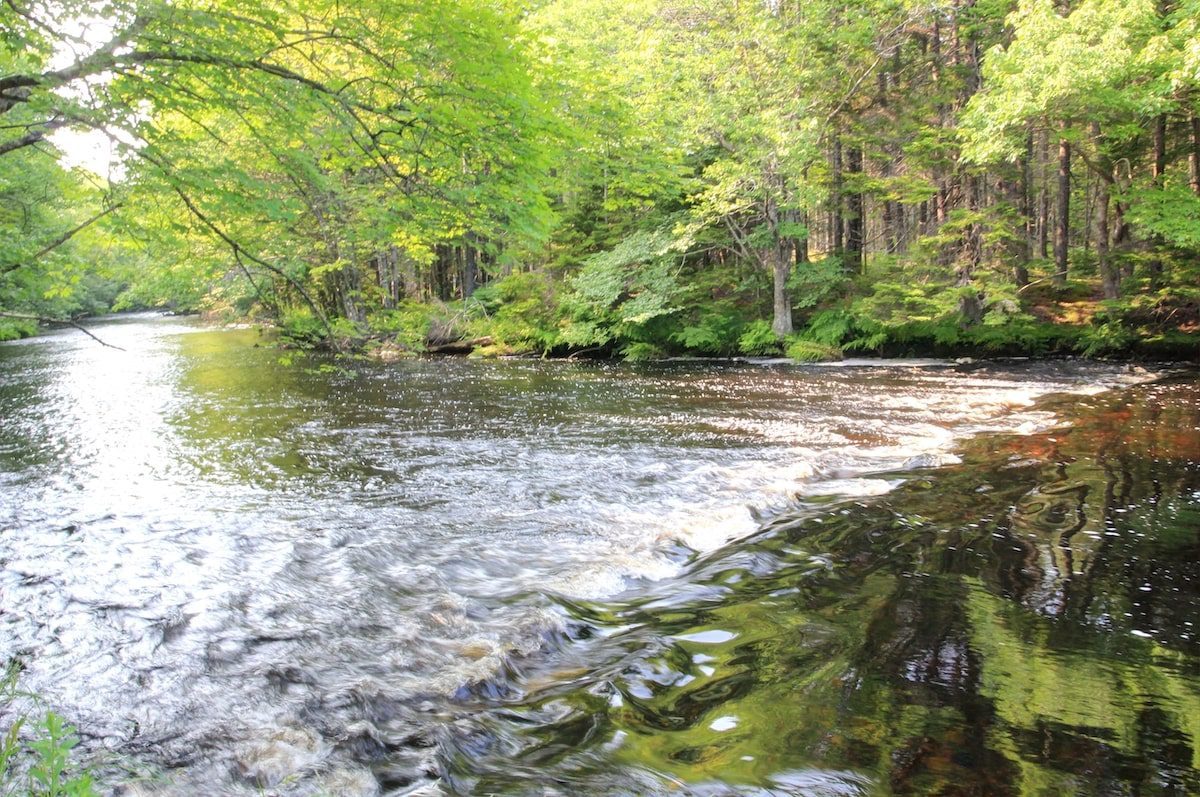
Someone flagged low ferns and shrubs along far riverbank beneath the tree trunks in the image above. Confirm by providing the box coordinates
[265,274,1200,362]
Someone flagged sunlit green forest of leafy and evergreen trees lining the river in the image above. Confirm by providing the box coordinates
[0,0,1200,360]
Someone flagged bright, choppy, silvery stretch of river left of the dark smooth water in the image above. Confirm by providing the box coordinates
[0,318,1161,795]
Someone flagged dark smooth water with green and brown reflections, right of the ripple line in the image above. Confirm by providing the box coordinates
[444,379,1200,795]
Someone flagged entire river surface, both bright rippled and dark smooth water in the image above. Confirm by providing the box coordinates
[0,316,1200,796]
